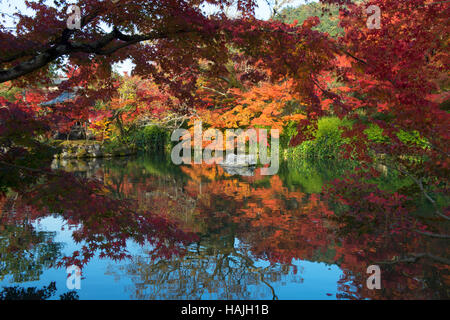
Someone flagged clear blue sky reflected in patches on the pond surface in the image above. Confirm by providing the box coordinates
[0,217,342,299]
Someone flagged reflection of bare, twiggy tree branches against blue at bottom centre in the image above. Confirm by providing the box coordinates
[109,241,303,300]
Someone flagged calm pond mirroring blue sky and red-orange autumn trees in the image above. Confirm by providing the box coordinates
[0,155,448,299]
